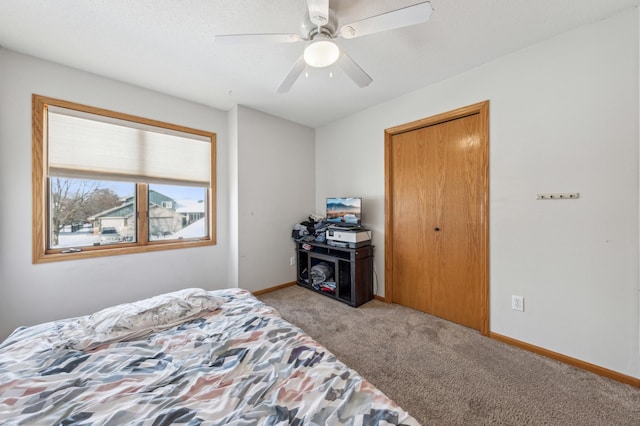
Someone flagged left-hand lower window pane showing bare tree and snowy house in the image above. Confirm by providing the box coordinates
[49,177,136,249]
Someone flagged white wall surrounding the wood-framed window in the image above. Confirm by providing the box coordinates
[0,48,234,340]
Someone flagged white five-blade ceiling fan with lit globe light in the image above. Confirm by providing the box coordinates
[214,0,433,93]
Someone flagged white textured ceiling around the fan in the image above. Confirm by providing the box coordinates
[0,0,640,127]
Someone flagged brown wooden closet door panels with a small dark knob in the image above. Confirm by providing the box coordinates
[388,107,488,330]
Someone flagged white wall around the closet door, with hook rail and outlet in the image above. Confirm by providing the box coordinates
[316,9,640,377]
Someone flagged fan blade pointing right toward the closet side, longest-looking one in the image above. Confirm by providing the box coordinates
[340,1,433,38]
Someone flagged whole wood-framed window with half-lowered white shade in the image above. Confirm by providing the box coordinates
[33,95,216,263]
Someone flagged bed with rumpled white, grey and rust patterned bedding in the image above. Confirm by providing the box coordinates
[0,289,418,426]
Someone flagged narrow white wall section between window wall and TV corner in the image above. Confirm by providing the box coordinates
[236,106,315,291]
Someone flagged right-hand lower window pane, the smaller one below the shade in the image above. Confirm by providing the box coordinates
[148,184,208,241]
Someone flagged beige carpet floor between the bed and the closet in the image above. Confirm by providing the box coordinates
[259,286,640,425]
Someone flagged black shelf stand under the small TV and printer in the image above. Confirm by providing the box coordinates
[296,242,373,307]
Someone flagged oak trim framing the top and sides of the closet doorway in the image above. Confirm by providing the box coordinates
[384,100,489,336]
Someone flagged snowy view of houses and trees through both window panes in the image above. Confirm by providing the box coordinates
[49,177,207,249]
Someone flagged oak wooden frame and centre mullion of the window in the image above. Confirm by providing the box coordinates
[32,94,216,264]
